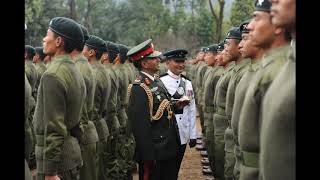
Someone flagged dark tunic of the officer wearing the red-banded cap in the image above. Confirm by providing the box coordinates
[128,73,180,180]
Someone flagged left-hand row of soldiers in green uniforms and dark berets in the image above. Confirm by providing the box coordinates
[25,17,138,180]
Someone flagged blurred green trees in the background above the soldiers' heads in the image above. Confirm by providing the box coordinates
[25,0,253,55]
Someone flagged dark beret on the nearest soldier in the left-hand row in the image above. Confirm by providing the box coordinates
[49,17,84,43]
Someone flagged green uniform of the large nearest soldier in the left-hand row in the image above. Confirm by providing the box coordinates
[34,55,86,180]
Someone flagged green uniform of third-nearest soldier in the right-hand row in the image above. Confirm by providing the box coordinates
[231,62,260,180]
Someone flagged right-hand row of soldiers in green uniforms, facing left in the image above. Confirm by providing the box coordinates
[182,0,295,180]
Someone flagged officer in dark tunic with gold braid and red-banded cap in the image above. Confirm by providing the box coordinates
[127,39,183,180]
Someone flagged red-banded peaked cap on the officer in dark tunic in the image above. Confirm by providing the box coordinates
[127,39,161,61]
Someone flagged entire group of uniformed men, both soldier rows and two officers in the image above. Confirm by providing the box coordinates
[25,0,295,180]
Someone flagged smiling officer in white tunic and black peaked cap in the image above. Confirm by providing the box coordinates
[160,49,196,177]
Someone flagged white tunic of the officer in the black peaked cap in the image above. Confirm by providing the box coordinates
[160,70,196,145]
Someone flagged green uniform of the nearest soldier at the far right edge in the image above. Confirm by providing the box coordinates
[260,41,296,180]
